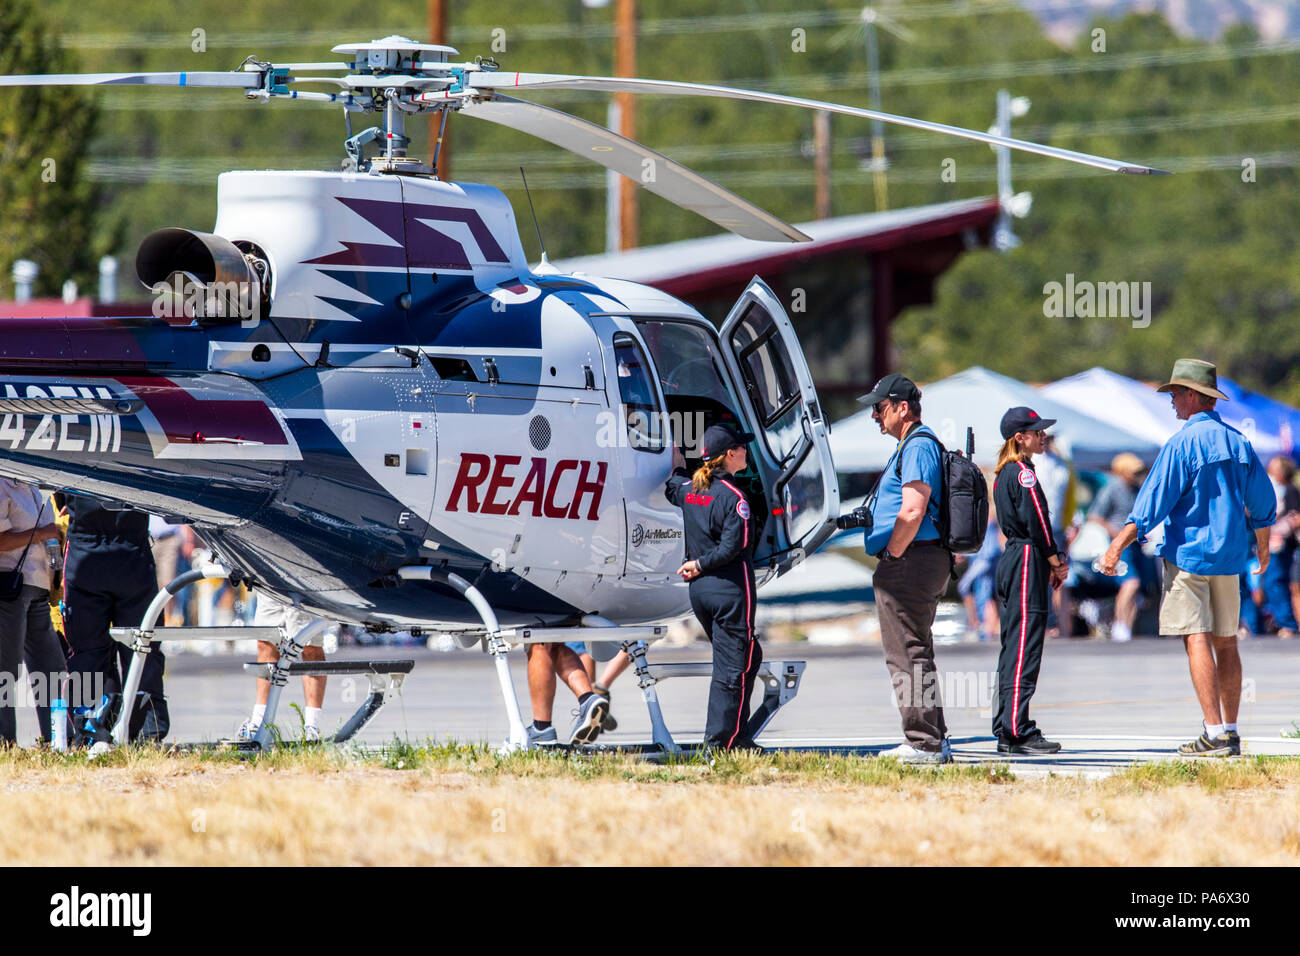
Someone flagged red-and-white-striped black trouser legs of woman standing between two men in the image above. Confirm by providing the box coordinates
[993,540,1052,744]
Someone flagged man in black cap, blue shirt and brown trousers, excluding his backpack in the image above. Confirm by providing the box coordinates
[858,373,953,763]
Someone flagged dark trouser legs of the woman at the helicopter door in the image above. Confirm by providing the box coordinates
[690,570,763,749]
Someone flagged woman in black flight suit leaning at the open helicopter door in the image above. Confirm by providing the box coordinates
[664,425,763,750]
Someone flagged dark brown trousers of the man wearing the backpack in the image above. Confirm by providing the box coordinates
[872,544,953,753]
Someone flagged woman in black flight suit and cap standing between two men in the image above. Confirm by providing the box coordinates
[993,406,1069,754]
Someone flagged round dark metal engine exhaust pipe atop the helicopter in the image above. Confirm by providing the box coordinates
[135,226,270,325]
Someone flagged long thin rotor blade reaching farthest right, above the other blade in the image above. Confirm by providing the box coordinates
[465,72,1169,176]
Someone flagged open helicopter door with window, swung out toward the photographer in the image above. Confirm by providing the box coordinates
[720,276,840,574]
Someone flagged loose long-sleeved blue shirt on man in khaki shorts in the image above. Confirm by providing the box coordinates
[1128,411,1277,575]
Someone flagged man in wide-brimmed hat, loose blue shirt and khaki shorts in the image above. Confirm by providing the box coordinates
[1101,359,1277,757]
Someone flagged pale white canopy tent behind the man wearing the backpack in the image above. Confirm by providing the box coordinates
[831,365,1160,473]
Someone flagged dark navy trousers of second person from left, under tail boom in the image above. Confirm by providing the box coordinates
[64,546,170,739]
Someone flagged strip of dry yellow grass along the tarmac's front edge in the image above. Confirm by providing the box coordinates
[0,745,1300,866]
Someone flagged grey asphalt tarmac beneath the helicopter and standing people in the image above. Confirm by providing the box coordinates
[20,629,1300,777]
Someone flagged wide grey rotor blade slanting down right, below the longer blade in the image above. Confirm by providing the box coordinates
[460,94,811,242]
